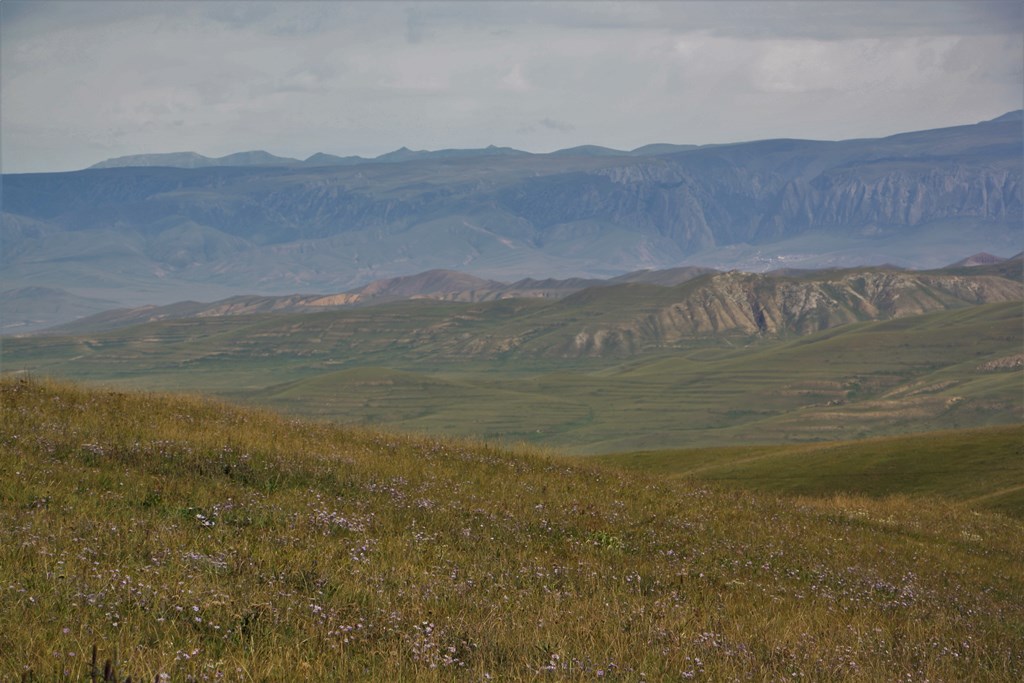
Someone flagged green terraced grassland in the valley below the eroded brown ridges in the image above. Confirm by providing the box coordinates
[3,301,1024,454]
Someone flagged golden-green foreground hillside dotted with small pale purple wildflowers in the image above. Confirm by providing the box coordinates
[0,379,1024,681]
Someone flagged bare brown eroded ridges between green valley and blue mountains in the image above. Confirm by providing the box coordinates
[34,257,1024,342]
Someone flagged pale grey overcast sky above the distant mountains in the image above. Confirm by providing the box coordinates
[0,0,1024,173]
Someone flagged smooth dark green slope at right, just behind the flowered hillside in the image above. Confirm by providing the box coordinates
[599,425,1024,517]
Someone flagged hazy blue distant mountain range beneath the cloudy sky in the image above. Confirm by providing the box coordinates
[0,112,1024,332]
